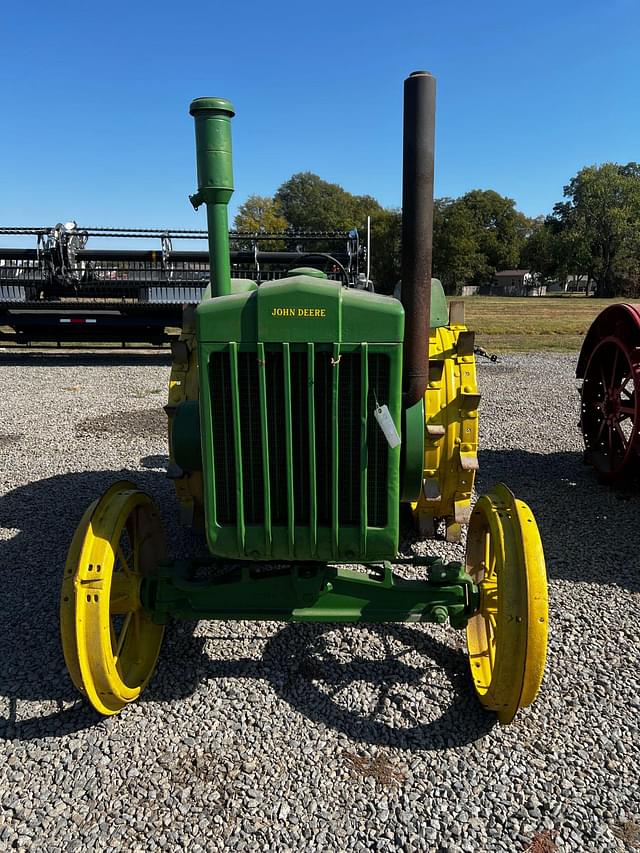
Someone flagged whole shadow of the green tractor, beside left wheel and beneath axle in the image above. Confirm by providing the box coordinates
[0,470,494,749]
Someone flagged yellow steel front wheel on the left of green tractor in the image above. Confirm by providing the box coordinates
[60,481,166,715]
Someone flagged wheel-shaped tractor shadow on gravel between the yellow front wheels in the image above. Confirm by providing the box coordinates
[145,623,496,750]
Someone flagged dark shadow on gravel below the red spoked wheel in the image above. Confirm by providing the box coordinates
[476,450,640,592]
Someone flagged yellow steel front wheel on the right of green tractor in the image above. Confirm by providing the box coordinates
[466,484,548,724]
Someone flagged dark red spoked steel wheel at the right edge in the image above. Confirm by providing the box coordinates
[580,334,640,482]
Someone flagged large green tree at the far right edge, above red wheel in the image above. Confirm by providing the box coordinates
[549,163,640,297]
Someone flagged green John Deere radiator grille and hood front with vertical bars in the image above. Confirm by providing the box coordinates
[192,275,403,562]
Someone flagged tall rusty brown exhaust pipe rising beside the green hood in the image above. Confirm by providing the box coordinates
[402,71,436,408]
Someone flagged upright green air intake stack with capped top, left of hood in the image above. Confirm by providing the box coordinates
[189,98,235,296]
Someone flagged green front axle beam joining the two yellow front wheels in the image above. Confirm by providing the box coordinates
[140,557,480,628]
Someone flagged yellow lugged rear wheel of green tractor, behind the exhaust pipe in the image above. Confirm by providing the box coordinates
[412,317,480,542]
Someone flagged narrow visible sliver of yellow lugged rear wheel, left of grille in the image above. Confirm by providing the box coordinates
[166,308,204,527]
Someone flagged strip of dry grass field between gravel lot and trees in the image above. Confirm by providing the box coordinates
[462,296,624,353]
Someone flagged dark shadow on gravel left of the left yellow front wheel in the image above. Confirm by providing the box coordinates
[0,470,186,739]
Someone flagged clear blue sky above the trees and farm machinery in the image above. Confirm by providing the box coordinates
[0,0,640,235]
